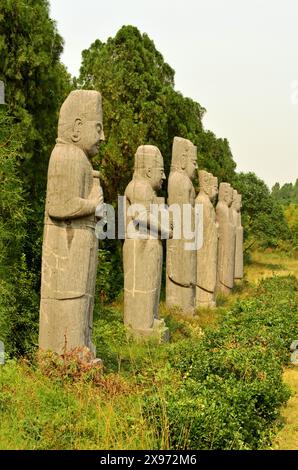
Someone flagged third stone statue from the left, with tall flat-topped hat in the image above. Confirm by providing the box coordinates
[166,137,197,314]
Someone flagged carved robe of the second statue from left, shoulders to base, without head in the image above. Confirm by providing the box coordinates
[123,175,163,336]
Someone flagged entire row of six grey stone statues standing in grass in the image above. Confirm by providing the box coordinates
[39,90,243,358]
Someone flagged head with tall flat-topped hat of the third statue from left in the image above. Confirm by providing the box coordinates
[171,137,198,179]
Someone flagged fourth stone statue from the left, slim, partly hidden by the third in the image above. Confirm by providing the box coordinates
[196,170,218,308]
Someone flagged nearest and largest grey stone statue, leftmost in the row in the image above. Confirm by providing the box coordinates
[39,90,104,357]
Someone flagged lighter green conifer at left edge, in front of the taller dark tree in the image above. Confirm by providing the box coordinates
[0,109,38,354]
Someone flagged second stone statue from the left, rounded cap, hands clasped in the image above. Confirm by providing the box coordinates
[123,145,170,340]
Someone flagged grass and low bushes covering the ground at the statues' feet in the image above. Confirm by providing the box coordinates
[0,253,298,449]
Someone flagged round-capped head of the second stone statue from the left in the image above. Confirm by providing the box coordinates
[134,145,166,191]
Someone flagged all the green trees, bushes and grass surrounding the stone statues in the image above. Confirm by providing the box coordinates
[0,0,298,449]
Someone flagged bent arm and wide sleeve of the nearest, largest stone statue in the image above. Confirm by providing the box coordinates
[47,151,97,219]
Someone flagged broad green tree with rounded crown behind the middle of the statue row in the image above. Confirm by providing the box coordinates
[78,26,235,202]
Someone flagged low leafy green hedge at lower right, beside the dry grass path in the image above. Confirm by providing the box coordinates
[145,277,298,450]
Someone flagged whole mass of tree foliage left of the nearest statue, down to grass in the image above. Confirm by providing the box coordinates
[0,0,71,354]
